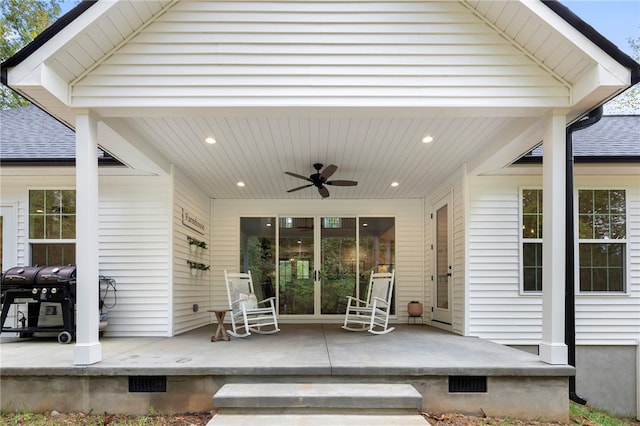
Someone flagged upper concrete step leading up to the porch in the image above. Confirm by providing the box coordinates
[213,383,422,414]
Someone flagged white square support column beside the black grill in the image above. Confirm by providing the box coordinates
[73,111,102,365]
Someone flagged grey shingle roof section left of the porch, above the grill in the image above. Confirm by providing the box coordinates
[0,105,120,164]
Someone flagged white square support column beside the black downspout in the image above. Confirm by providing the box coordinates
[539,111,568,364]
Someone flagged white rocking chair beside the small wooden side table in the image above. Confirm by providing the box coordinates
[224,271,280,337]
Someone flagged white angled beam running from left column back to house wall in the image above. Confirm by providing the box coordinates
[98,119,171,175]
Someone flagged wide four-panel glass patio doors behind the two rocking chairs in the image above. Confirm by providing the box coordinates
[240,216,395,319]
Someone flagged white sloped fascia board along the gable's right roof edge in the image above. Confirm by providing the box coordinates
[521,1,631,86]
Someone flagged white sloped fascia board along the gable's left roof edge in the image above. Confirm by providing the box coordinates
[7,0,117,96]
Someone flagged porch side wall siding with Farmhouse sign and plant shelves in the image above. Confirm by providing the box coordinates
[172,165,213,334]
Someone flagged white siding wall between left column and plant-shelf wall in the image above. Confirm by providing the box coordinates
[99,176,171,337]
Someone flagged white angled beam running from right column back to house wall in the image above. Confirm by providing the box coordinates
[467,119,544,176]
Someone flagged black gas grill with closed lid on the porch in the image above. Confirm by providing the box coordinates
[0,265,76,343]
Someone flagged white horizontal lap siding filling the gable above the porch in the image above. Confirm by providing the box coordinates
[70,1,570,106]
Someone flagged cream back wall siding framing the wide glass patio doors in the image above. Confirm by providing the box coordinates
[212,199,425,321]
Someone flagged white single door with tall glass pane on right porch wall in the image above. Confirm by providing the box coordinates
[432,195,452,324]
